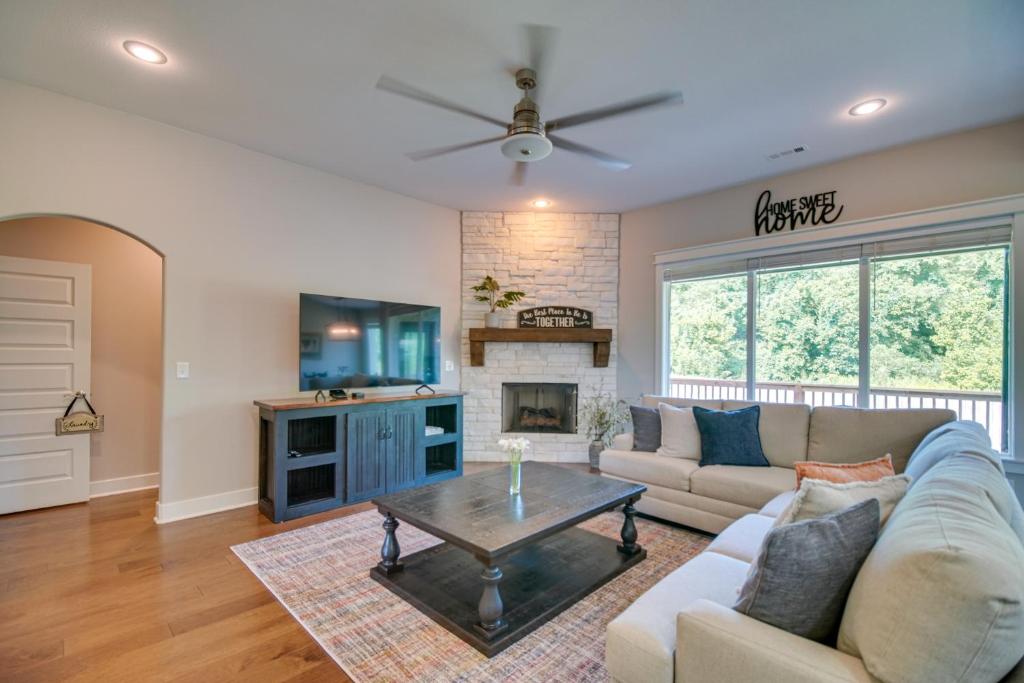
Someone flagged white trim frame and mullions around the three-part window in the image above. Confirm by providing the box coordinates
[654,195,1024,462]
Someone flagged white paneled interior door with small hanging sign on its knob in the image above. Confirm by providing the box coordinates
[0,256,92,514]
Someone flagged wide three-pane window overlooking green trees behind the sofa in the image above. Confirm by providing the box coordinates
[665,227,1011,451]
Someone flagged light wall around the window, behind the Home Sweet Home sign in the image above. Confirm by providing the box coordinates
[618,119,1024,398]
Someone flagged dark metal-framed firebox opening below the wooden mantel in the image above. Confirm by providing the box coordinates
[502,382,577,434]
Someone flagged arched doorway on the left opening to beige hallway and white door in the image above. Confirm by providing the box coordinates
[0,215,164,511]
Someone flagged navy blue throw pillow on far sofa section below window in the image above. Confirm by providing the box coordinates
[693,405,769,467]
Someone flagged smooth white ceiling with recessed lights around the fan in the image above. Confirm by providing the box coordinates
[0,0,1024,211]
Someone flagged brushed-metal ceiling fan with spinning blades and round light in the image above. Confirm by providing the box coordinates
[377,25,683,185]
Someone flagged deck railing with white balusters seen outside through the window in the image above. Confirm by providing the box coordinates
[669,377,1007,452]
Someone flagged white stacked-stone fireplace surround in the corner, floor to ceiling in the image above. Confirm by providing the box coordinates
[462,211,618,463]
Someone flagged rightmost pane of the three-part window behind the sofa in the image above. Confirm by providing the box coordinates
[870,247,1009,451]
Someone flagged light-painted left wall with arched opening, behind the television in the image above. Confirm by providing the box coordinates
[0,80,461,518]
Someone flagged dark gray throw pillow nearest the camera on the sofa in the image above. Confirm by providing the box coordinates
[733,498,880,642]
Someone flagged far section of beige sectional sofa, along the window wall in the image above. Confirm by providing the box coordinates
[600,396,956,533]
